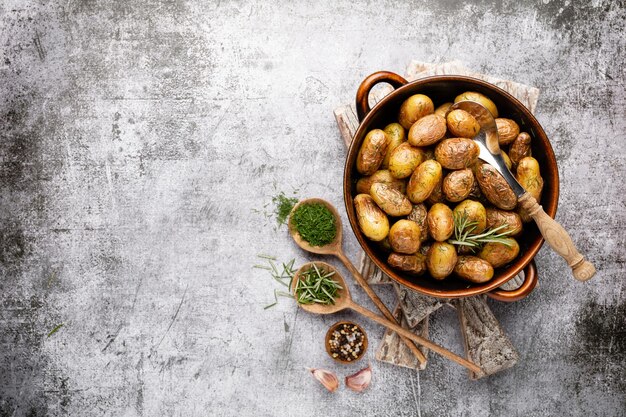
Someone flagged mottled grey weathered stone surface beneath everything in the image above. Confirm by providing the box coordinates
[0,0,626,416]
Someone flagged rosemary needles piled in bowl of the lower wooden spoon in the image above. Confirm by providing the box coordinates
[295,264,343,305]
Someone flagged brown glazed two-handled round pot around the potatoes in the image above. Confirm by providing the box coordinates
[343,71,559,301]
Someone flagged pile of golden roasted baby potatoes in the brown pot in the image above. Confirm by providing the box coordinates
[354,91,543,283]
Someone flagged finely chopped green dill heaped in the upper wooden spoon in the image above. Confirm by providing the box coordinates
[291,203,337,246]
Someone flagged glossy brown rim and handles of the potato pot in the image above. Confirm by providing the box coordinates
[343,73,559,301]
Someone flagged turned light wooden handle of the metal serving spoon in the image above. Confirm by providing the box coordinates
[518,192,596,281]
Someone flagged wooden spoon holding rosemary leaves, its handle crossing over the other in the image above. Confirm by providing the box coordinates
[291,262,482,373]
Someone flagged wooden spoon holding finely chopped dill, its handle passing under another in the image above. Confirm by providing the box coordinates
[289,198,426,365]
